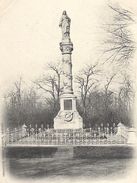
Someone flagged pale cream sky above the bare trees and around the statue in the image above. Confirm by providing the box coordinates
[0,0,137,94]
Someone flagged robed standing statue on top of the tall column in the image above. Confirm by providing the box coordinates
[59,11,71,40]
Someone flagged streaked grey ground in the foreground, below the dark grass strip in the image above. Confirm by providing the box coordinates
[7,158,133,179]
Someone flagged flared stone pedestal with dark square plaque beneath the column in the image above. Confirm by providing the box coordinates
[54,94,83,129]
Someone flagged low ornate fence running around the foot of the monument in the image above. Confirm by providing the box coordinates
[2,123,128,145]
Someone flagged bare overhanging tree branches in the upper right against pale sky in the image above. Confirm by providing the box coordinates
[104,5,135,64]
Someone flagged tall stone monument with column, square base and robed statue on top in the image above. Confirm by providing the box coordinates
[54,11,83,129]
